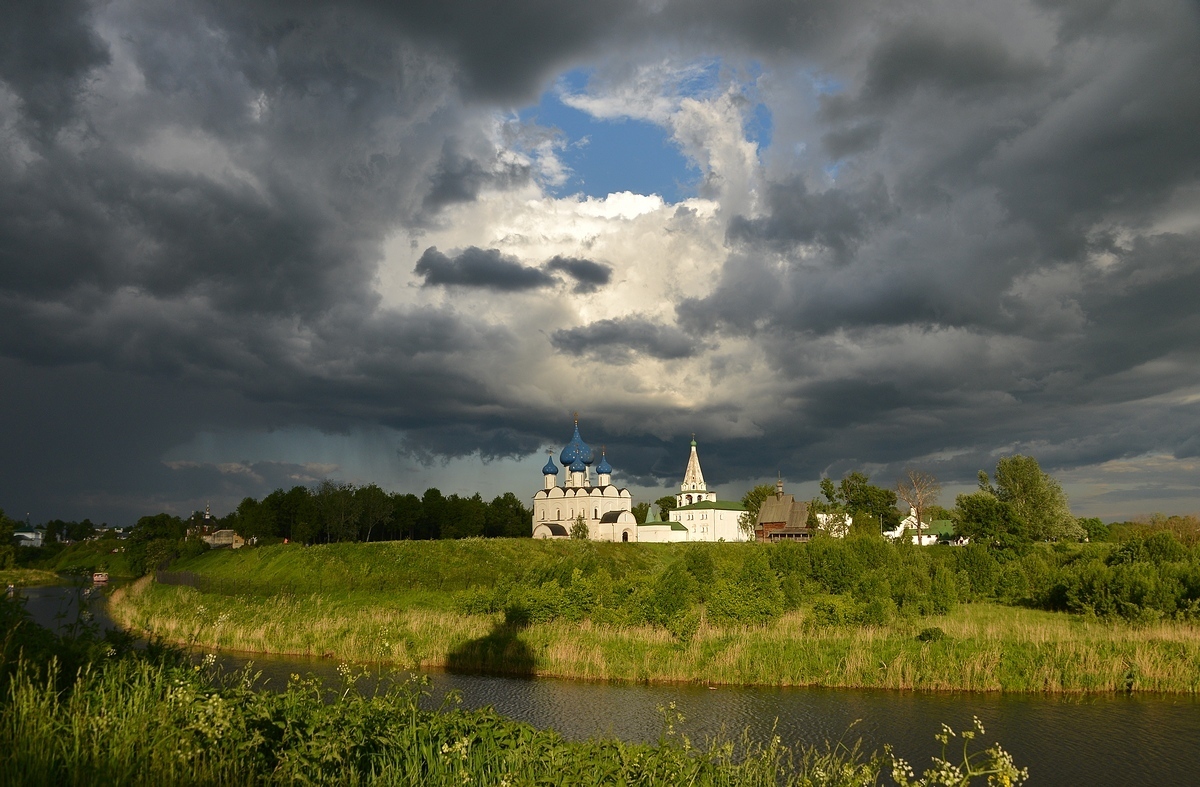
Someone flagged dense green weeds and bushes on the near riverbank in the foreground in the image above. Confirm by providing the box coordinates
[0,592,1025,787]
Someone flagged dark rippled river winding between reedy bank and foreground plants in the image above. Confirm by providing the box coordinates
[22,588,1200,787]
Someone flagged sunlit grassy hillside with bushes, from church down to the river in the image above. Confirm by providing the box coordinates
[112,540,1200,693]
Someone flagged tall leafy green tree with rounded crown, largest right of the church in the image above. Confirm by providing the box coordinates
[980,455,1086,541]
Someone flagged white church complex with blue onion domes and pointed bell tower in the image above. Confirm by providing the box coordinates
[533,417,754,542]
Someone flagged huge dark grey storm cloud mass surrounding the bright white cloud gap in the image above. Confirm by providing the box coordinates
[0,0,1200,518]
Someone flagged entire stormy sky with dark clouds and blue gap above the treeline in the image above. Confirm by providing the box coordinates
[0,0,1200,523]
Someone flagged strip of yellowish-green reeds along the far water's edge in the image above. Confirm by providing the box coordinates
[109,579,1200,693]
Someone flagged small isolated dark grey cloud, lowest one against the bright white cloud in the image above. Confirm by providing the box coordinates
[550,317,703,364]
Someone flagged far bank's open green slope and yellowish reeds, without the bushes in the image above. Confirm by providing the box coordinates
[110,540,1200,693]
